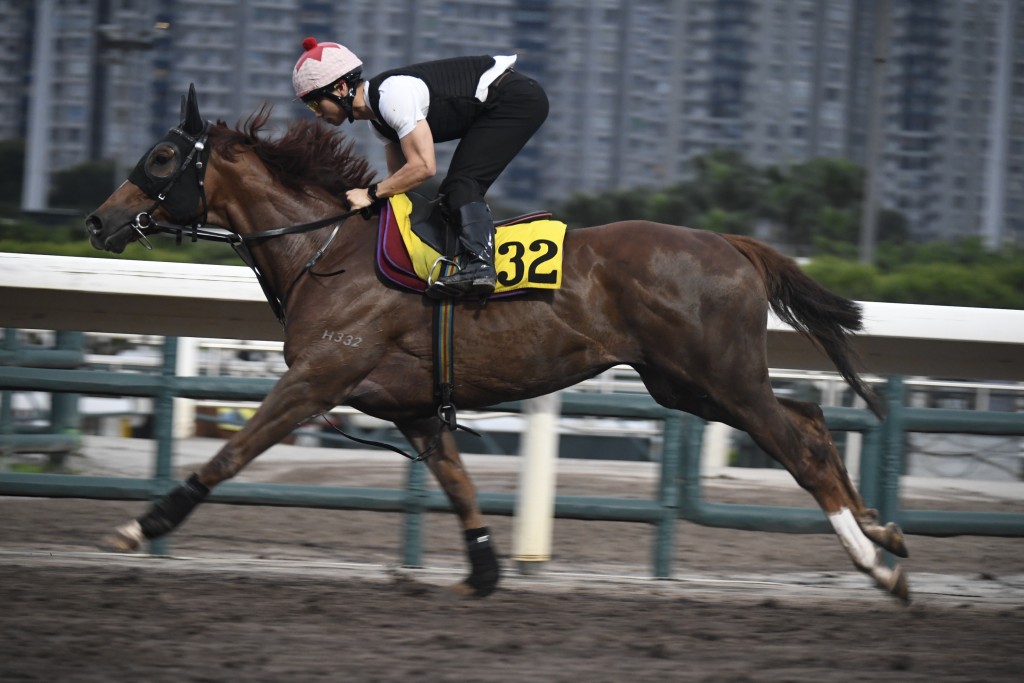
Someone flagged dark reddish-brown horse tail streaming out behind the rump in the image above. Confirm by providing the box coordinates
[722,234,886,420]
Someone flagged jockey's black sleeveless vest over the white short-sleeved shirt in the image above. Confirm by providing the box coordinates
[367,55,495,142]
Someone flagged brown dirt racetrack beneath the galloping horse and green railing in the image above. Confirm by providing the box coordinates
[0,440,1024,683]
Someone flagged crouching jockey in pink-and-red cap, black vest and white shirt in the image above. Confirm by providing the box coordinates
[292,38,548,298]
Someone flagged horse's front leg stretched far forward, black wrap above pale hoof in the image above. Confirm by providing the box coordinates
[99,370,335,552]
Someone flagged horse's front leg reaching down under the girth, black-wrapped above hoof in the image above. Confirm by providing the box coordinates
[396,418,501,598]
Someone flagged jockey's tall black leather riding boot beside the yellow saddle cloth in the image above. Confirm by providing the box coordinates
[427,202,497,298]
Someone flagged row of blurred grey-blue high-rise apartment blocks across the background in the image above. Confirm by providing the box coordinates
[0,0,1024,246]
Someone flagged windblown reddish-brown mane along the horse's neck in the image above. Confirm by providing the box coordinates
[209,104,376,199]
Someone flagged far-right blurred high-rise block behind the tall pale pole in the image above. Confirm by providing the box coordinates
[880,0,1024,246]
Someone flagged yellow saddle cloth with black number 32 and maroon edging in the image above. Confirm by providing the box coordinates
[377,195,565,296]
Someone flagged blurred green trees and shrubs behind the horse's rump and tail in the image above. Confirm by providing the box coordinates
[556,150,1024,308]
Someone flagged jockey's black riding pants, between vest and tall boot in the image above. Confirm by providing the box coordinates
[439,72,548,211]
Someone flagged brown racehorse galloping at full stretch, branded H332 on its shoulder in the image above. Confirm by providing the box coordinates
[86,90,908,600]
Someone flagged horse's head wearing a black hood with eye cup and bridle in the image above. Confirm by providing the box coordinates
[85,84,210,254]
